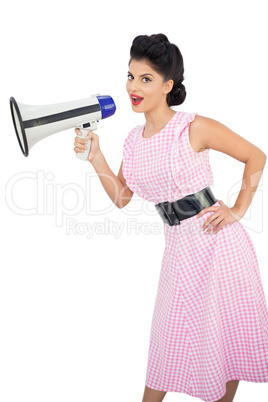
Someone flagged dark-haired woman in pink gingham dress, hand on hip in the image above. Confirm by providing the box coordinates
[74,34,268,402]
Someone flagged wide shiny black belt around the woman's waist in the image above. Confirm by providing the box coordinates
[155,187,217,226]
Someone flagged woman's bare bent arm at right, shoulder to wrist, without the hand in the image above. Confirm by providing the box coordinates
[190,115,267,217]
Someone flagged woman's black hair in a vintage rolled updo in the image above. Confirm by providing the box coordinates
[129,34,186,106]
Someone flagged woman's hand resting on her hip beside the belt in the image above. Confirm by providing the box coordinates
[196,199,243,234]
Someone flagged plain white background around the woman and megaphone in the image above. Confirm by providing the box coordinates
[0,0,268,402]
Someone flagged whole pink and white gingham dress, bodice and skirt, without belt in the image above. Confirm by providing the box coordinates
[123,111,268,402]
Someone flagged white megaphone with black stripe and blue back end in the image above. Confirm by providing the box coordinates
[10,94,116,161]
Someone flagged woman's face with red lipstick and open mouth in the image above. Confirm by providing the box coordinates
[126,59,173,113]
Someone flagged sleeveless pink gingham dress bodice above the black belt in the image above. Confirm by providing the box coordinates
[123,112,213,204]
